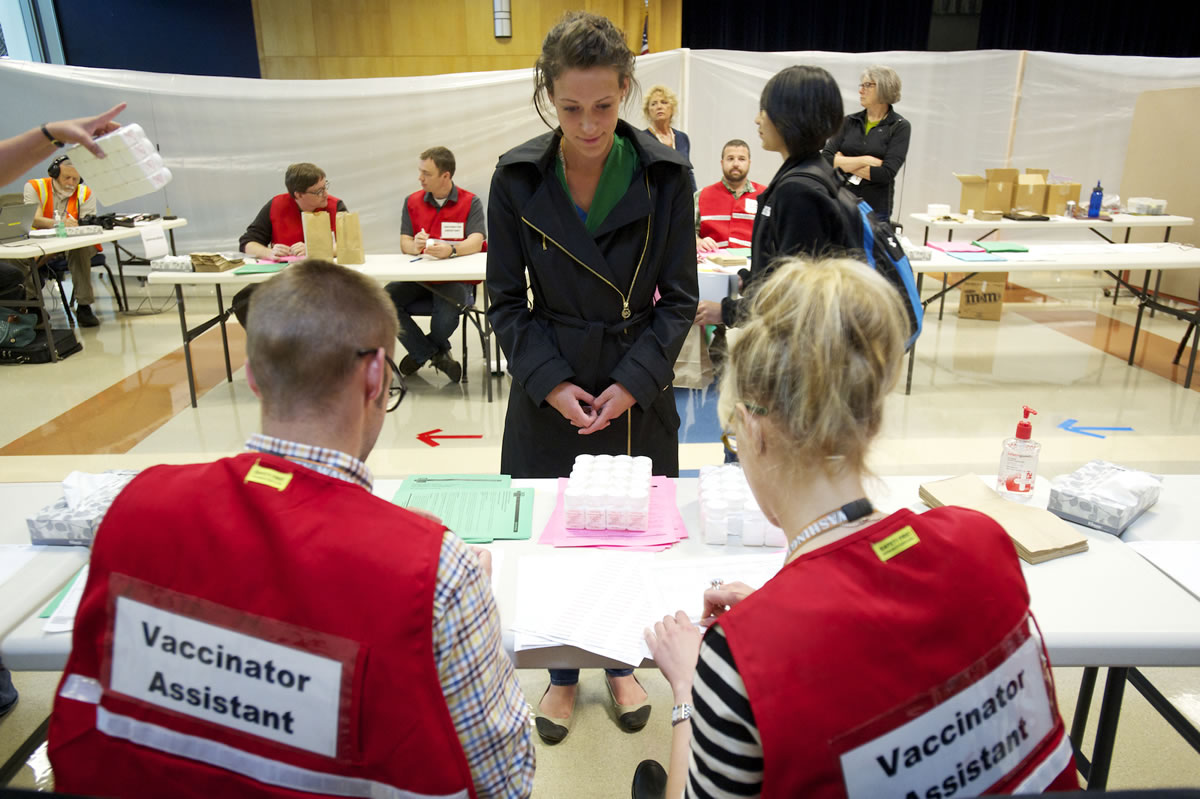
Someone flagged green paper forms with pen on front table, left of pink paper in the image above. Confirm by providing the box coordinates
[392,475,534,543]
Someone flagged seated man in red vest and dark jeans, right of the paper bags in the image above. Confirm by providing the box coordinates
[386,148,487,383]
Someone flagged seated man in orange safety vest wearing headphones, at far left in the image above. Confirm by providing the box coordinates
[12,156,100,328]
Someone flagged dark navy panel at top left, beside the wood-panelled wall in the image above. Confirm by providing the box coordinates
[54,0,259,78]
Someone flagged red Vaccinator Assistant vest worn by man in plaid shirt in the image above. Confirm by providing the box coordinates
[49,452,475,799]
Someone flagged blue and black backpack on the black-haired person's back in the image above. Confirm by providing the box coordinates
[793,166,925,352]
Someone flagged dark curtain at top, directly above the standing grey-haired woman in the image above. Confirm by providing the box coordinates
[682,0,932,53]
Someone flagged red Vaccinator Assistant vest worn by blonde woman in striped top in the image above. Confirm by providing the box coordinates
[720,507,1079,799]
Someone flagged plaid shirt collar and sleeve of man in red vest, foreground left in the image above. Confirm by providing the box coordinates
[246,433,534,798]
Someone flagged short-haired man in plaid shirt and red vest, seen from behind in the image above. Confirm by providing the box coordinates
[49,260,534,799]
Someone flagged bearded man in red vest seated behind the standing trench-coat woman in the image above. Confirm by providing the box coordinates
[696,139,767,325]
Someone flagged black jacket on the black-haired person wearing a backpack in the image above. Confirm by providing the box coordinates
[721,154,857,326]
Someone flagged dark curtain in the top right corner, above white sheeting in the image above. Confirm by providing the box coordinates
[978,0,1200,56]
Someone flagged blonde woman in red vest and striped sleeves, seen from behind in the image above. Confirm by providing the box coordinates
[635,258,1078,799]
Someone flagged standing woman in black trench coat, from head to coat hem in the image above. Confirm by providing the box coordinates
[487,20,697,477]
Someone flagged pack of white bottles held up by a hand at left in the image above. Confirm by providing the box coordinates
[67,122,172,205]
